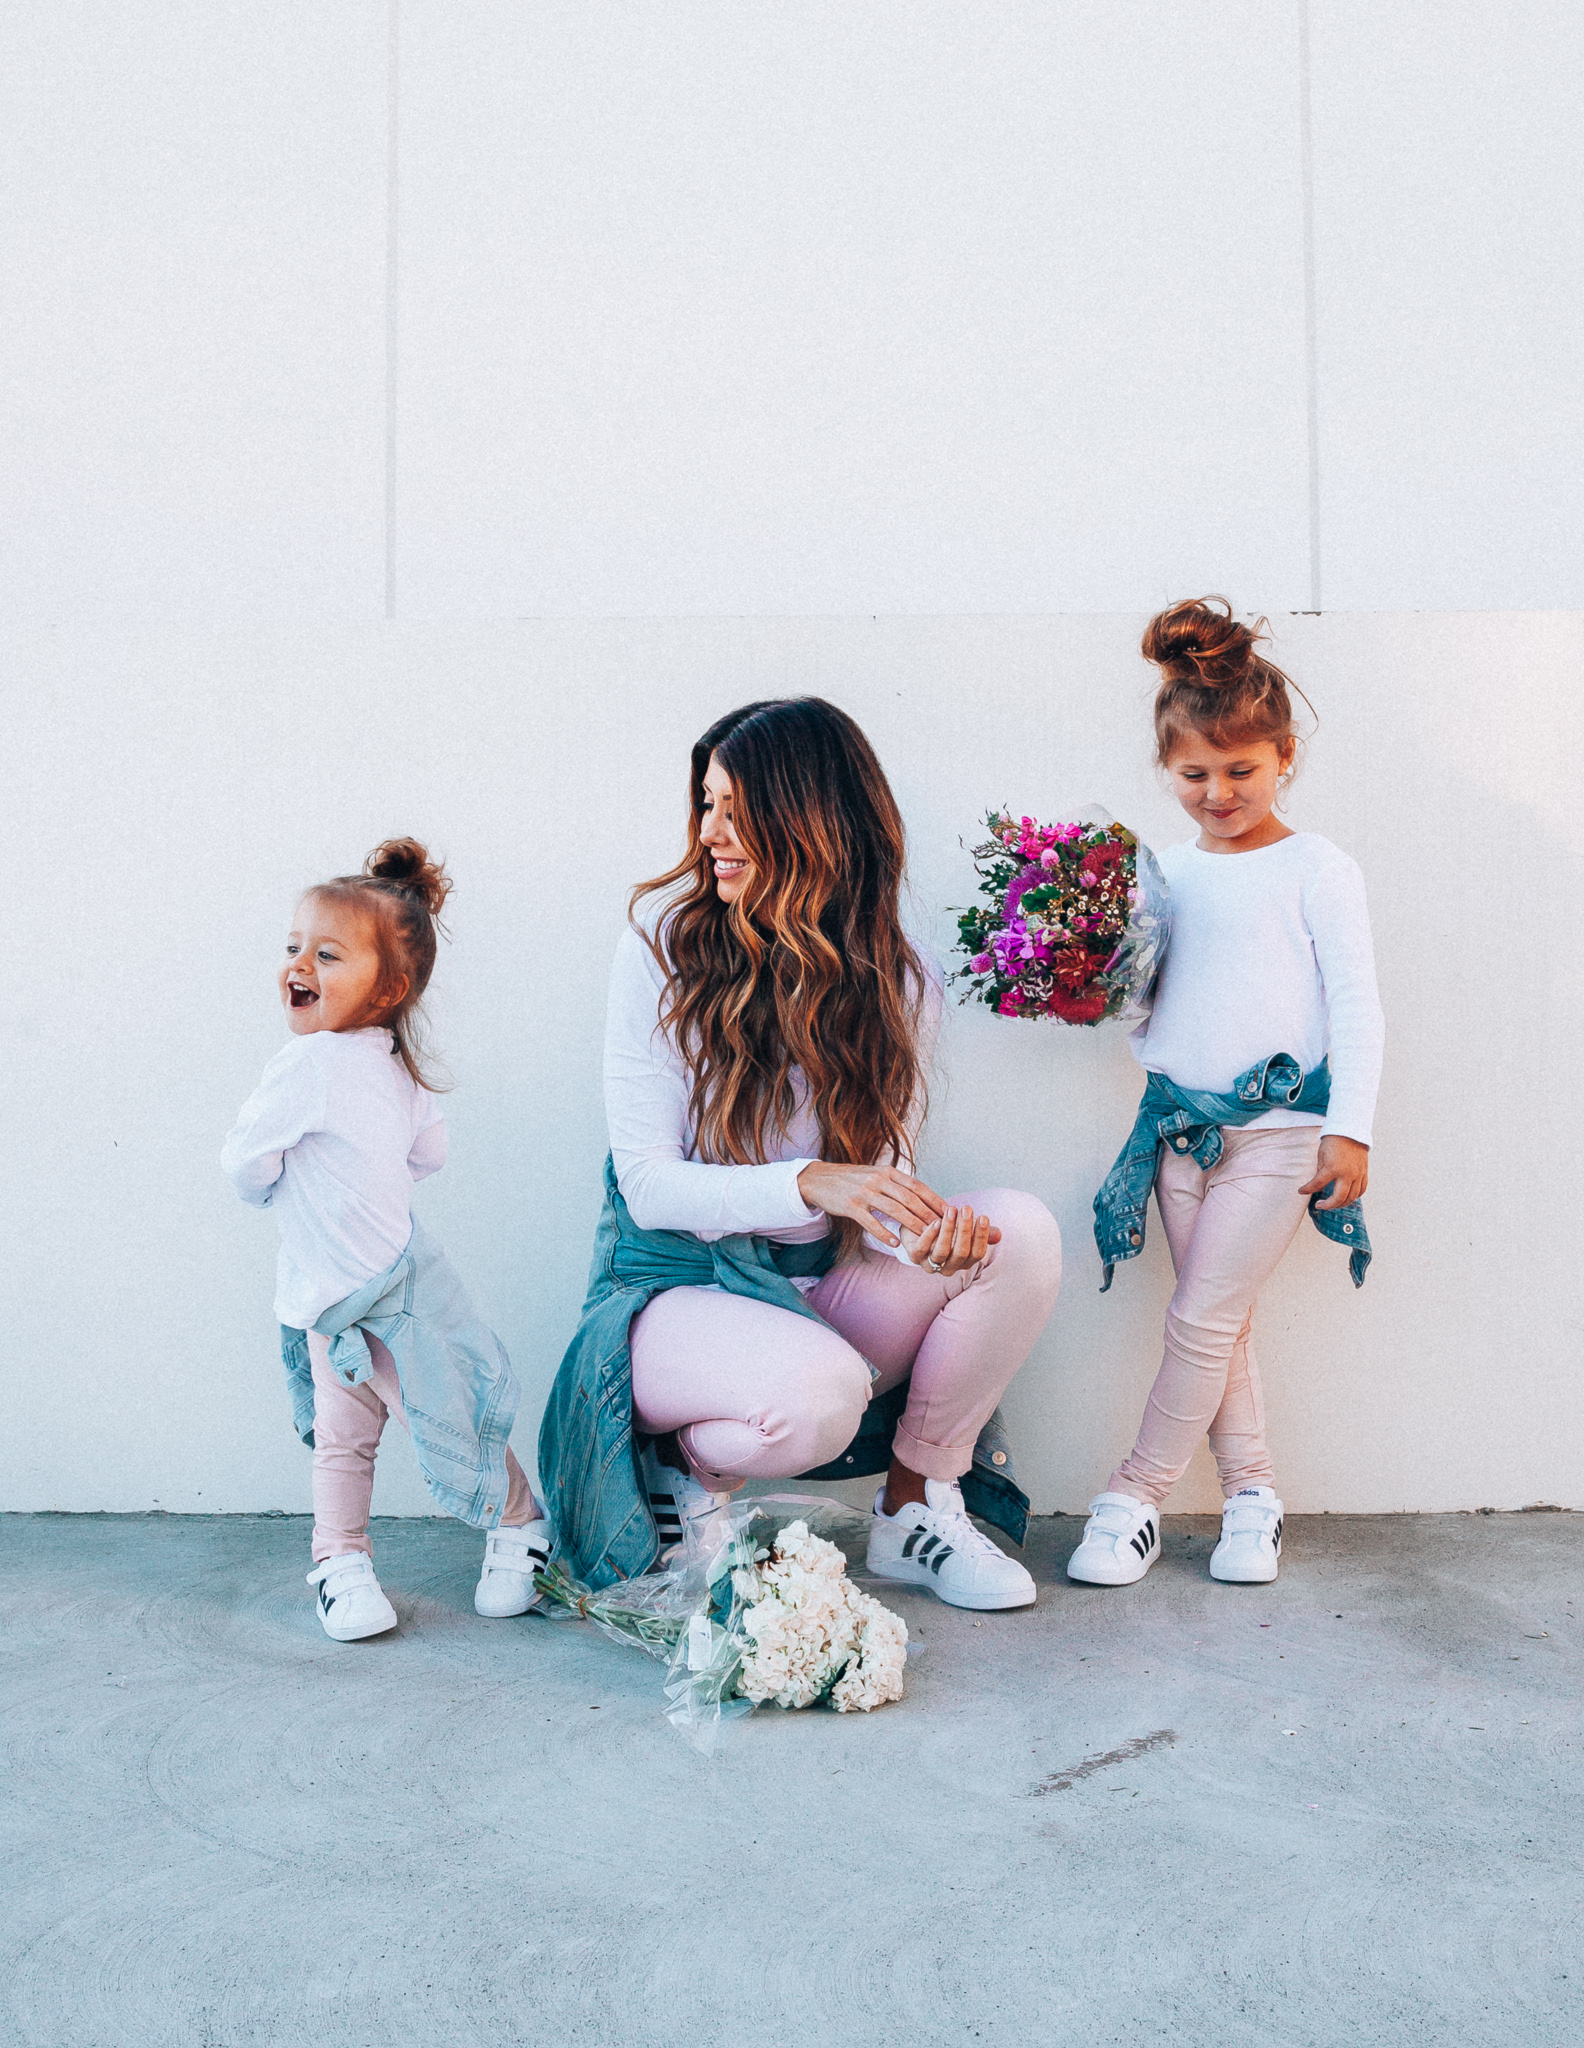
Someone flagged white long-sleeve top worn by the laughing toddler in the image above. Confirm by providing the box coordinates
[219,1028,447,1329]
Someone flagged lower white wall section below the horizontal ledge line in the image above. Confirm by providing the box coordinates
[12,614,1584,1509]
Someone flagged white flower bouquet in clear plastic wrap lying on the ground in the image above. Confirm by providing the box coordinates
[537,1493,908,1751]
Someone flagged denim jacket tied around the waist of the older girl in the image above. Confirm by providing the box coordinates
[1094,1053,1371,1294]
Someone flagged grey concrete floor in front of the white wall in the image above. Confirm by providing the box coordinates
[0,1513,1584,2048]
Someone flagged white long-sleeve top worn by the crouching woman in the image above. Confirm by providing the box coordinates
[605,926,941,1243]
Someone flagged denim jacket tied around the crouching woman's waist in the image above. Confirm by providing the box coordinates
[539,1157,1029,1589]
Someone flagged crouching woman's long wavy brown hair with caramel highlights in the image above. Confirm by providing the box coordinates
[631,696,926,1255]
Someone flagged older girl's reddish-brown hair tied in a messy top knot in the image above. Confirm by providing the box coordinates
[1141,598,1314,768]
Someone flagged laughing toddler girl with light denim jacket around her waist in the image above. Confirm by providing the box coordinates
[221,840,549,1642]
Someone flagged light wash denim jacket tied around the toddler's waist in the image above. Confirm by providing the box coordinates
[281,1223,523,1530]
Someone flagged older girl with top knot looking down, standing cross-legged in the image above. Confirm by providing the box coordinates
[1068,598,1383,1585]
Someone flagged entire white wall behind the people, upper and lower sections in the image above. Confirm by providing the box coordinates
[0,0,1584,1511]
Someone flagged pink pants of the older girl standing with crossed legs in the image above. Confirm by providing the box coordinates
[1107,1124,1320,1507]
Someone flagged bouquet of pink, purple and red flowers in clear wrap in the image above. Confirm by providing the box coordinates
[953,811,1172,1024]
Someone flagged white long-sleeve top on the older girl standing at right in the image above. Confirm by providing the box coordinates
[1133,831,1385,1145]
